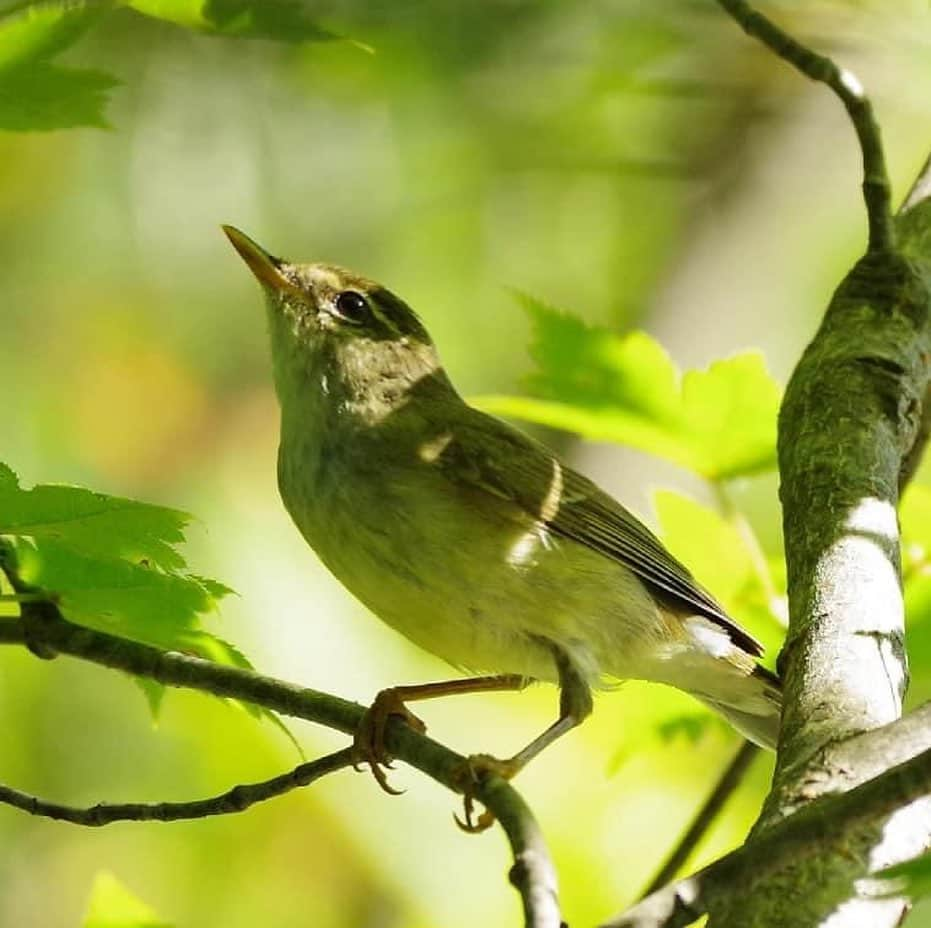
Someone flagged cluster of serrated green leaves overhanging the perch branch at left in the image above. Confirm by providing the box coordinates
[0,464,301,753]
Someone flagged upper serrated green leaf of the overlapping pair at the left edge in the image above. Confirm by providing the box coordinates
[0,465,191,568]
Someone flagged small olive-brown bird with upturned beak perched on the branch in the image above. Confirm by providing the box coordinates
[223,226,782,804]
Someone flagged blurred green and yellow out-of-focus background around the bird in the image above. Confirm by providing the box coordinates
[0,0,931,928]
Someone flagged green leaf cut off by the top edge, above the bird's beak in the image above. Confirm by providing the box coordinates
[128,0,340,42]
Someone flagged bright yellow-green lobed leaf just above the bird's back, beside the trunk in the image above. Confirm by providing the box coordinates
[475,296,781,480]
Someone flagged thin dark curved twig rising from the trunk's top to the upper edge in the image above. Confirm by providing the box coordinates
[718,0,895,252]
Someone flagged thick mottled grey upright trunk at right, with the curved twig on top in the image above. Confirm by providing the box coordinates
[704,52,931,912]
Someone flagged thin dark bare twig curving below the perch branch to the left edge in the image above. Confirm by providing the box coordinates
[0,748,352,828]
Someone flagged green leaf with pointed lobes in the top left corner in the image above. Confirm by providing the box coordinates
[0,0,119,132]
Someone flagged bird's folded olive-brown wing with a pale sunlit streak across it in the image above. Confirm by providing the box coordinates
[436,409,763,655]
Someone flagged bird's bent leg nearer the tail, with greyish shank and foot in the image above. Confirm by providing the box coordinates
[456,642,592,834]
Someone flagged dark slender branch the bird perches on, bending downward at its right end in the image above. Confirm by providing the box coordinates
[0,604,562,928]
